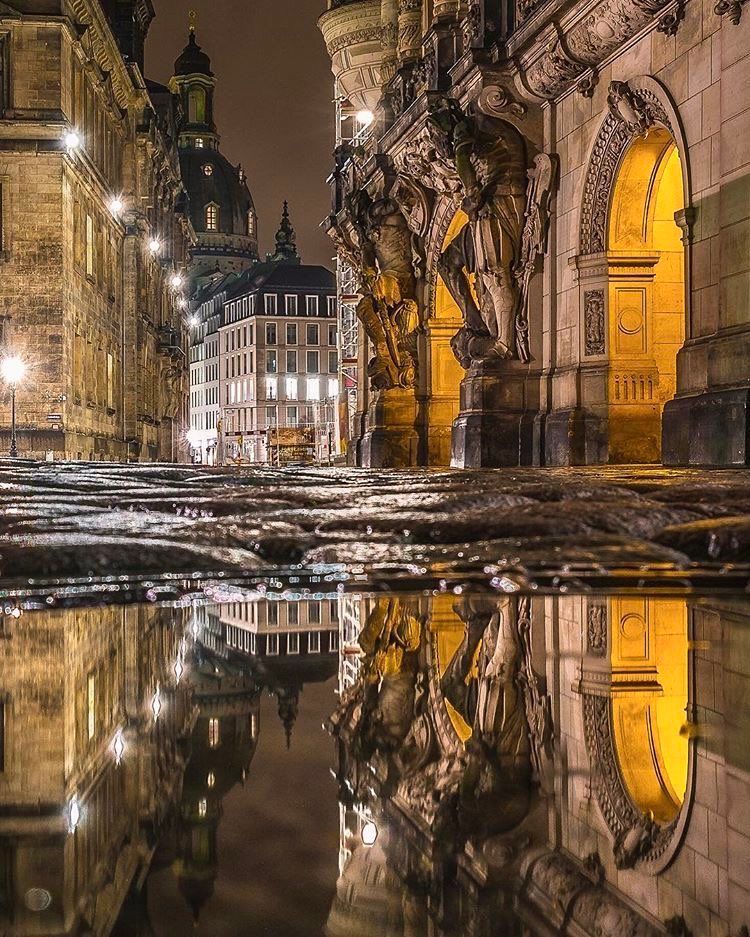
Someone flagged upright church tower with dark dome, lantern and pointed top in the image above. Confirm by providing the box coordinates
[169,18,258,288]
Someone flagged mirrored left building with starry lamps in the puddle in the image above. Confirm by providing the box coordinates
[0,607,197,937]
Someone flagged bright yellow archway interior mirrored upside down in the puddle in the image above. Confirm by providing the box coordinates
[609,598,689,823]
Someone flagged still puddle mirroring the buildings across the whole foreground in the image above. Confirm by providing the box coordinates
[0,591,750,937]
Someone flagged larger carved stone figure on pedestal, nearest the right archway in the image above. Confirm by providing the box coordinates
[428,98,530,368]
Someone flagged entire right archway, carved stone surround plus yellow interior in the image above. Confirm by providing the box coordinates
[575,78,691,463]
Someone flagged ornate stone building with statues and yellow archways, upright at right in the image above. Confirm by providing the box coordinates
[320,0,750,466]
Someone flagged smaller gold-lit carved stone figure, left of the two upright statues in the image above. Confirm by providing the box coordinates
[332,189,422,390]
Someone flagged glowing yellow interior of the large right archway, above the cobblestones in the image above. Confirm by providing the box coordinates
[601,127,685,463]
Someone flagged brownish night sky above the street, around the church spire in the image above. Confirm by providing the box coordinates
[146,0,334,268]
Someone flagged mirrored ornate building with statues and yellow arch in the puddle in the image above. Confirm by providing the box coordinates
[326,594,750,937]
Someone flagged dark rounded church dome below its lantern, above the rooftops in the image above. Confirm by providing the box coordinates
[180,146,255,237]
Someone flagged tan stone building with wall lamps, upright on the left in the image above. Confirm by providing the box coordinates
[0,0,194,461]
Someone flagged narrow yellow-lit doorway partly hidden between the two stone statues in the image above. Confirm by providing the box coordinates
[426,210,469,466]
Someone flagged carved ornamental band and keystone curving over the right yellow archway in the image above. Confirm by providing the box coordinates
[581,82,672,254]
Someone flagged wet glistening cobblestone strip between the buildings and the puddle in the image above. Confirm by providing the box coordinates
[0,461,750,582]
